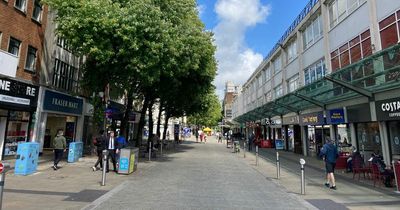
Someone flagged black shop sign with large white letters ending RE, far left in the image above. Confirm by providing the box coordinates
[0,78,39,107]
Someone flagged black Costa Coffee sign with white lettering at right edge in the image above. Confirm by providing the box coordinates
[375,98,400,120]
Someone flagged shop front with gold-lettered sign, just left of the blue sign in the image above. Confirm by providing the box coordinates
[300,111,324,157]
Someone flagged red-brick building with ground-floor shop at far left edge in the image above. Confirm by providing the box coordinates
[0,0,47,157]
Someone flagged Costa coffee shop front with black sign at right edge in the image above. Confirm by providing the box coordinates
[375,98,400,162]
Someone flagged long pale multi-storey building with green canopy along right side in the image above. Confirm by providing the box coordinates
[233,0,400,166]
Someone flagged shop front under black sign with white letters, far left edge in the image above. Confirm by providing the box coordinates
[0,78,39,158]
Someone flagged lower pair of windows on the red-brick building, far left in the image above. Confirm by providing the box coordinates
[8,37,37,72]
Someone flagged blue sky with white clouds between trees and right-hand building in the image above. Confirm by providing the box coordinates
[197,0,309,99]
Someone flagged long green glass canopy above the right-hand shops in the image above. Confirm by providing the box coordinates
[234,44,400,123]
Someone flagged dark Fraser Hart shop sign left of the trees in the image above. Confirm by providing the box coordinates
[43,90,83,115]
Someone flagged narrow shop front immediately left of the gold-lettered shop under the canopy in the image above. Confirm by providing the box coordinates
[282,115,303,154]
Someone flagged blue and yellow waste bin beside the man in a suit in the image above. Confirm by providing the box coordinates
[118,147,139,174]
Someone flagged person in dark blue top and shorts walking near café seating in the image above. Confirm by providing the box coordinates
[320,139,339,190]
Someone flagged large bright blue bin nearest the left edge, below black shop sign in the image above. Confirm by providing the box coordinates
[14,142,39,175]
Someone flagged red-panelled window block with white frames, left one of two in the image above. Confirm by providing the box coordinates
[331,29,372,72]
